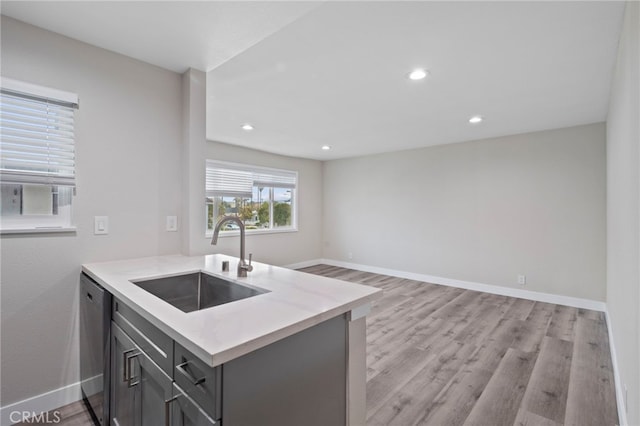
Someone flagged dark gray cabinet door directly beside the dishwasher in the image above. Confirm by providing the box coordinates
[110,323,137,426]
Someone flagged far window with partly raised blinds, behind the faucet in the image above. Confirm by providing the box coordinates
[206,160,298,233]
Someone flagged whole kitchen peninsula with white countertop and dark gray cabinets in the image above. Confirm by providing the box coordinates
[82,255,380,426]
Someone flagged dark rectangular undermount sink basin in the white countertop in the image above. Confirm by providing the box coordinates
[131,272,267,312]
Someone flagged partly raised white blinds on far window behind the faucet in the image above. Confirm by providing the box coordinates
[206,160,298,198]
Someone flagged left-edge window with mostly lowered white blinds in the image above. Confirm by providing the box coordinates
[0,77,78,232]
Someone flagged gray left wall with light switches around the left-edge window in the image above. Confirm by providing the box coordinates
[0,16,182,408]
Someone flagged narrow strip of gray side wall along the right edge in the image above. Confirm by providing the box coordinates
[607,2,640,425]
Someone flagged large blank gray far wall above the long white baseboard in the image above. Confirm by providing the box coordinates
[324,123,605,301]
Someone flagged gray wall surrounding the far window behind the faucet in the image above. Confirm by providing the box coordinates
[197,141,323,266]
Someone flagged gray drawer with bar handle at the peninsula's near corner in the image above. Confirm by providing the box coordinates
[173,343,222,420]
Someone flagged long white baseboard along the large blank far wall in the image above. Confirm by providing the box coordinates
[314,259,606,312]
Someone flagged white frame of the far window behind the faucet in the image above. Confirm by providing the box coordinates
[204,159,299,239]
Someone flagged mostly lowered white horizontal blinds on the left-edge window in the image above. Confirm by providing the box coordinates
[0,78,78,186]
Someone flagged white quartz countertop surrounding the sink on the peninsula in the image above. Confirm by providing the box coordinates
[82,254,381,367]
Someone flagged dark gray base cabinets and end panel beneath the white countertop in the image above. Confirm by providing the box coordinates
[110,299,348,426]
